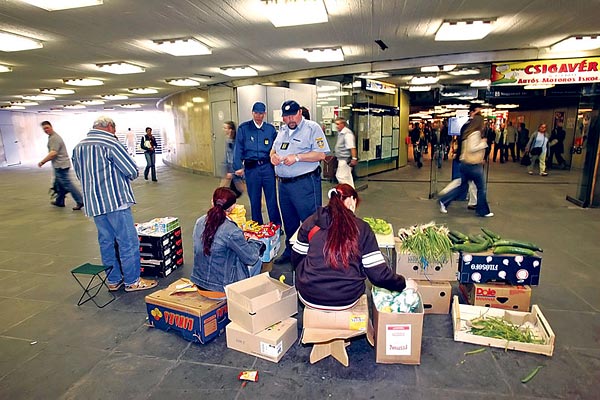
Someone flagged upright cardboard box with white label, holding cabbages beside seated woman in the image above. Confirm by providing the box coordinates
[373,290,424,365]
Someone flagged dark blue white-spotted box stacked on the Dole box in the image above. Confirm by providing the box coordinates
[459,253,542,311]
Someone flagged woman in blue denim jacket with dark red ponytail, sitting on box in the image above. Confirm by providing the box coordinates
[190,187,265,292]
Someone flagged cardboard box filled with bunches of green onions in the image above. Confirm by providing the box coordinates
[396,222,458,282]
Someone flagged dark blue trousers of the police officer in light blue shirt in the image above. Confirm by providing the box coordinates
[279,174,322,254]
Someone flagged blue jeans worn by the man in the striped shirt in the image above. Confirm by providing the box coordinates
[94,208,140,285]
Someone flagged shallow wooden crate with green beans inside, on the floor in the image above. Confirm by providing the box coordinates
[452,296,556,356]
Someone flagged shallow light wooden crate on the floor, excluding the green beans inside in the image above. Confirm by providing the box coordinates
[452,296,556,356]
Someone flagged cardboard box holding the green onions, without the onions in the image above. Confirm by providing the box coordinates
[396,242,458,282]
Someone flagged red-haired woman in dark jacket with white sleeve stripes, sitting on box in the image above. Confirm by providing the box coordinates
[292,184,416,310]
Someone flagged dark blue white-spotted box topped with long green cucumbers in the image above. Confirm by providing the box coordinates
[448,228,543,286]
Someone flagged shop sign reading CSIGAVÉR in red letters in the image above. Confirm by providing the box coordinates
[491,57,600,86]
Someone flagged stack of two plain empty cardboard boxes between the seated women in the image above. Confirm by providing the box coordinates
[225,273,298,362]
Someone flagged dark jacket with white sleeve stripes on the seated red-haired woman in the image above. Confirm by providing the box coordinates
[292,207,406,306]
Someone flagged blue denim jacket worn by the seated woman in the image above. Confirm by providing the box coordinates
[191,215,262,292]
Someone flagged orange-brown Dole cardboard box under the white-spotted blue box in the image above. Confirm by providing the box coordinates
[460,283,531,311]
